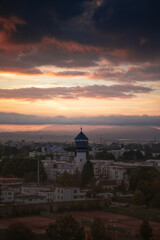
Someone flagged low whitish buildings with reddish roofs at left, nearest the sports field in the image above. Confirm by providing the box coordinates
[0,178,86,204]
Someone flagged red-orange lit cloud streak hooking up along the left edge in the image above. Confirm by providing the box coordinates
[0,16,104,52]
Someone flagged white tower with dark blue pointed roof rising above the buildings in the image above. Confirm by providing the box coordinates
[74,128,88,172]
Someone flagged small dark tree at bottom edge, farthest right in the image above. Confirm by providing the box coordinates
[139,219,152,240]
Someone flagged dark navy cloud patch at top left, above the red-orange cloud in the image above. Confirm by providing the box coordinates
[0,0,91,42]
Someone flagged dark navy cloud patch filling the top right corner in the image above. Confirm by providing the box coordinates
[93,0,160,58]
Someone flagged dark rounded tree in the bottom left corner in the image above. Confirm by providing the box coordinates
[6,222,35,240]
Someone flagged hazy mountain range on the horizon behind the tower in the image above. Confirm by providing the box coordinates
[0,126,160,142]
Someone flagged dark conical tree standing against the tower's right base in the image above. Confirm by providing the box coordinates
[81,160,94,186]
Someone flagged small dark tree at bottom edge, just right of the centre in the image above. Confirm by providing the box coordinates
[91,218,111,240]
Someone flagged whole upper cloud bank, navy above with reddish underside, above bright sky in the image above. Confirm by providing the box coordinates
[0,0,160,75]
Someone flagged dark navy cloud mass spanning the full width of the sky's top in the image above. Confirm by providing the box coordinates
[0,0,160,55]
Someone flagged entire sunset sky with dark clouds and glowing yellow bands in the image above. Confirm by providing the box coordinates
[0,0,160,130]
